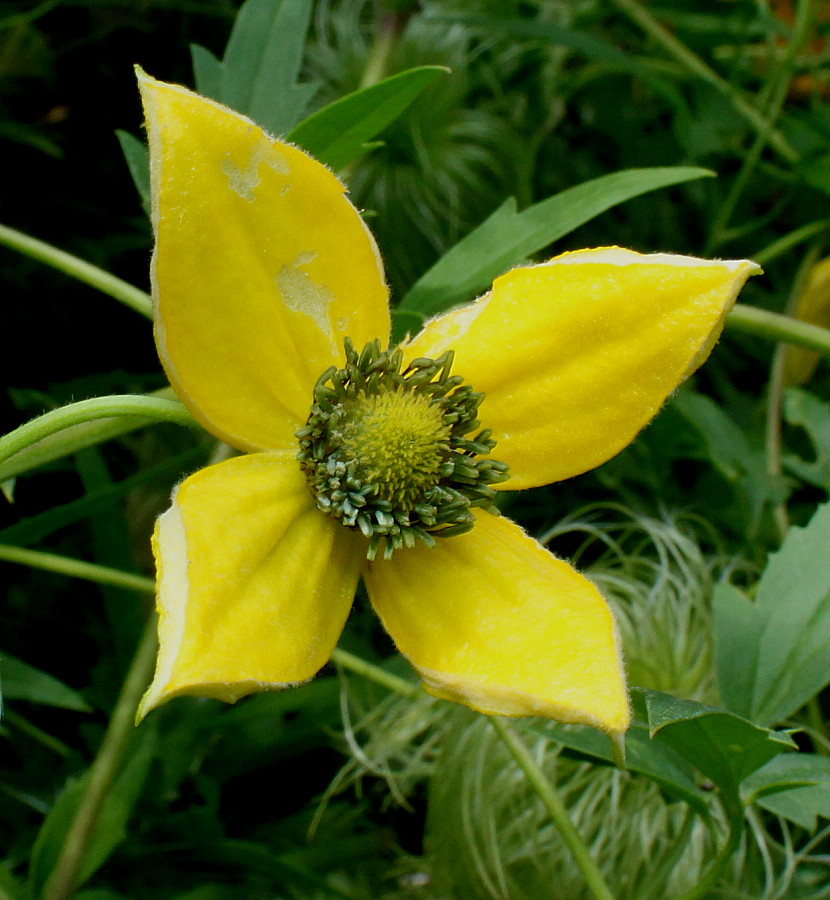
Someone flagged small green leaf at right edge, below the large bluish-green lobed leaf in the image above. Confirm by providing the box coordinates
[742,753,830,831]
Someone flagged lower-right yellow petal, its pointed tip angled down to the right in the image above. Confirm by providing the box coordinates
[364,512,629,735]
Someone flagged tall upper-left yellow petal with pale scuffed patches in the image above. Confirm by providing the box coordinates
[140,70,389,450]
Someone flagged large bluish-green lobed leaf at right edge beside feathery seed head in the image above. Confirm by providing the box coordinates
[714,504,830,725]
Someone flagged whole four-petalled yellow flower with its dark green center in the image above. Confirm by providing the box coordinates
[135,77,758,736]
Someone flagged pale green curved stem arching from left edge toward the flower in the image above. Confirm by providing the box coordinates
[0,394,196,472]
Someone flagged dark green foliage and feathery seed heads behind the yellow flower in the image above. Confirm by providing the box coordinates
[0,0,830,900]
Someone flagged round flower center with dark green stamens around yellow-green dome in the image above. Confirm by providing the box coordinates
[297,338,507,559]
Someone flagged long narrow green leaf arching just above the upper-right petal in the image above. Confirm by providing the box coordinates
[401,166,713,315]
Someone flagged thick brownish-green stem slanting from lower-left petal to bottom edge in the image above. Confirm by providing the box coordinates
[42,619,156,900]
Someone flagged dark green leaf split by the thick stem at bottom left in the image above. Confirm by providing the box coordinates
[30,726,157,897]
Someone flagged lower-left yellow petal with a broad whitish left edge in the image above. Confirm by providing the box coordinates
[139,453,365,716]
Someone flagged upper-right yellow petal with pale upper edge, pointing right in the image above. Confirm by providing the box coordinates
[406,247,760,489]
